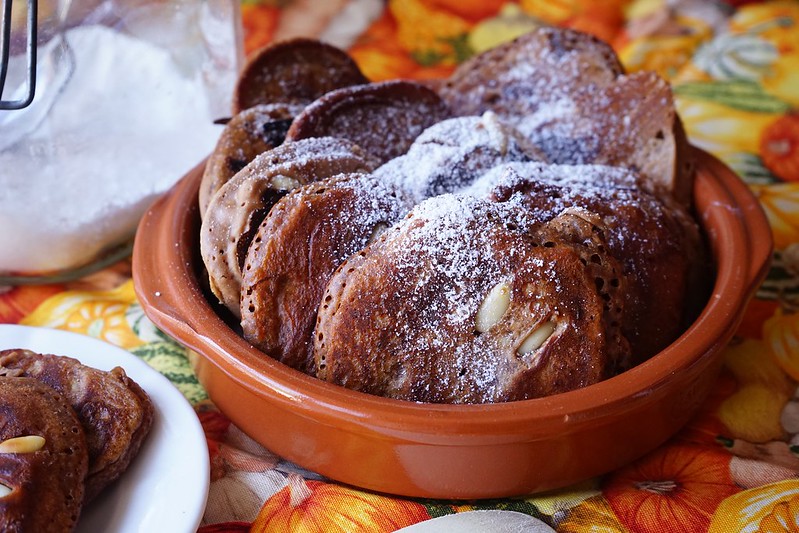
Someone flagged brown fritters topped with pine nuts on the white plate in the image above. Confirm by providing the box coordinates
[0,349,154,533]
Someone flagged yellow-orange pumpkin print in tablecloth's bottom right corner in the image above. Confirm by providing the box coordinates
[708,479,799,533]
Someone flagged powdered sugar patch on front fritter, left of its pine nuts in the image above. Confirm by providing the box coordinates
[366,194,557,401]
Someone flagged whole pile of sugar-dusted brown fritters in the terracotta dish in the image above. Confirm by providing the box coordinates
[201,27,709,403]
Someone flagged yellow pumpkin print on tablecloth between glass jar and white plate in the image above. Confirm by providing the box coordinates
[20,281,144,349]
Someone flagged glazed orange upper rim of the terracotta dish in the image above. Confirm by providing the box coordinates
[133,145,772,432]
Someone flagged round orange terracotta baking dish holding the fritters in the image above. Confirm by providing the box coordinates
[133,150,772,499]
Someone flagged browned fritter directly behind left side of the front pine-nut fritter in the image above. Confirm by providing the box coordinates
[241,174,410,373]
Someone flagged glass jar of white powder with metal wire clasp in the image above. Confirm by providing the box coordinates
[0,0,243,285]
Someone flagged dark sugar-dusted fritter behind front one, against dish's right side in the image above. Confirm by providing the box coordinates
[489,164,707,363]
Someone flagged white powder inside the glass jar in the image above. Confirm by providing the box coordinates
[0,26,228,273]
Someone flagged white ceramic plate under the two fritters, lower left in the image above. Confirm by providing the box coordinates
[0,324,210,533]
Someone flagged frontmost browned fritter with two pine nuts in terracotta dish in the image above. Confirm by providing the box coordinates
[314,197,629,403]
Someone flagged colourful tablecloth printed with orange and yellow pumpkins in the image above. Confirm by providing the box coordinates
[0,0,799,532]
